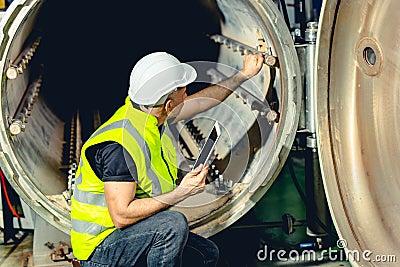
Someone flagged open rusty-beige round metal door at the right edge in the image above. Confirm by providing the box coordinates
[316,0,400,266]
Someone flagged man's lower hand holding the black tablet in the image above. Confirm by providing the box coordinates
[176,164,208,197]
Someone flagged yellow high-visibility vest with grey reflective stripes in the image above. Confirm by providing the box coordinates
[71,97,178,260]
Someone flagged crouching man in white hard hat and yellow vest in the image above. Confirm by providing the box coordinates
[71,52,264,266]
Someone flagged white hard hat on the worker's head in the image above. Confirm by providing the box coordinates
[128,52,197,105]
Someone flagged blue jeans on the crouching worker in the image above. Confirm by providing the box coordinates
[80,210,219,267]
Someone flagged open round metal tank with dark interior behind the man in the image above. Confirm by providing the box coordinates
[0,0,301,239]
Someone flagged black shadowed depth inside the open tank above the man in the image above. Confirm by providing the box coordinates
[34,0,223,139]
